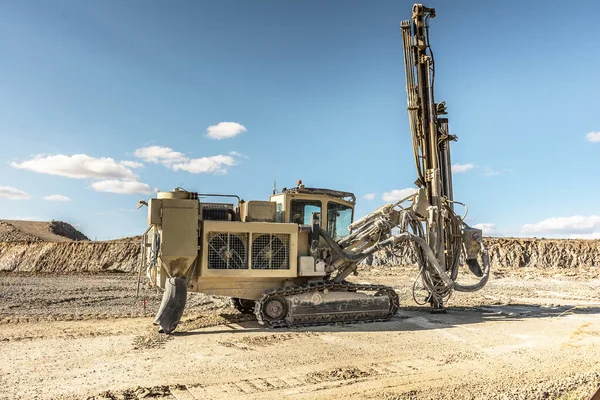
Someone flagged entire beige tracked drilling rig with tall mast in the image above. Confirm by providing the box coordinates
[140,4,489,333]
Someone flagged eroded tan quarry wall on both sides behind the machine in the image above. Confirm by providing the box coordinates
[0,238,600,273]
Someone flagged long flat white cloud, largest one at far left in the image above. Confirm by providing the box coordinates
[10,154,137,180]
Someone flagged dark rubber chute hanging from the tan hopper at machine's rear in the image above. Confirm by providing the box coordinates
[154,277,187,334]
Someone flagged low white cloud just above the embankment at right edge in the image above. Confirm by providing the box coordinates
[521,215,600,237]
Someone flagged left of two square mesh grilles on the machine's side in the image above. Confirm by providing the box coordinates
[208,232,248,269]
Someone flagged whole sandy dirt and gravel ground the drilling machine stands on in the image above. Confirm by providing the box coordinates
[0,268,600,400]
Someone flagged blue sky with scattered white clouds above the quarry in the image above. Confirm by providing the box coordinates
[0,0,600,239]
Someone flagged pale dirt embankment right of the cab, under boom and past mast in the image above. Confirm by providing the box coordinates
[367,237,600,269]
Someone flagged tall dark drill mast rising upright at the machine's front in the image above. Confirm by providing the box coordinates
[401,4,460,306]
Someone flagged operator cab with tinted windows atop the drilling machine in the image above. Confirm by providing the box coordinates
[270,181,356,240]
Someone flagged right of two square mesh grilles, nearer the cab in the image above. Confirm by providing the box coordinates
[252,233,290,269]
